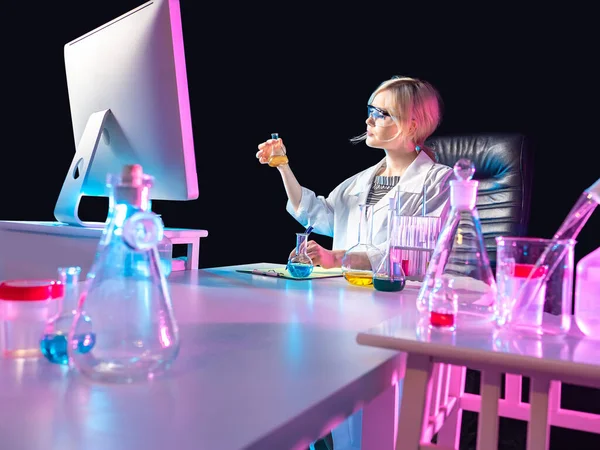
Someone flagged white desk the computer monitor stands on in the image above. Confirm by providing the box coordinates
[0,220,208,280]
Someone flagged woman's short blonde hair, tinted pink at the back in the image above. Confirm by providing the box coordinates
[351,76,442,155]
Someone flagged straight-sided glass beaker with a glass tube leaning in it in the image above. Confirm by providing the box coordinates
[494,236,575,335]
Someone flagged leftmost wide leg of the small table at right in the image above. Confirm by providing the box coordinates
[396,353,433,450]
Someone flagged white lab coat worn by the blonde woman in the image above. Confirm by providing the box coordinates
[286,152,452,450]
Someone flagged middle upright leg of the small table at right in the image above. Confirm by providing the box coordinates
[477,370,502,450]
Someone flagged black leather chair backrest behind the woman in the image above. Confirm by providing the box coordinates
[426,133,533,267]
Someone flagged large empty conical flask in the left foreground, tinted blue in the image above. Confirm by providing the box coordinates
[69,165,179,382]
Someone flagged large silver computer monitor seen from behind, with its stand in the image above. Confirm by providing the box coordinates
[54,0,198,226]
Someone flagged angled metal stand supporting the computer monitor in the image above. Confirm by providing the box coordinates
[54,109,118,228]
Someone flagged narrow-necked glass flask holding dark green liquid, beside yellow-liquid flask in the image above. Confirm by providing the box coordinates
[373,197,406,292]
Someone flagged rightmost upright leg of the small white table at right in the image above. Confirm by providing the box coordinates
[527,377,550,450]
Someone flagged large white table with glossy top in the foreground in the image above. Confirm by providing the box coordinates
[0,264,414,450]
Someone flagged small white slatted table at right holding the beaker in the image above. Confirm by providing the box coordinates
[357,310,600,450]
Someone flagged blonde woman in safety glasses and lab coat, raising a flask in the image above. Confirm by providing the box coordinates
[256,77,453,450]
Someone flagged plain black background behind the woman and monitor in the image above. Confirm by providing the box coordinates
[0,0,600,448]
